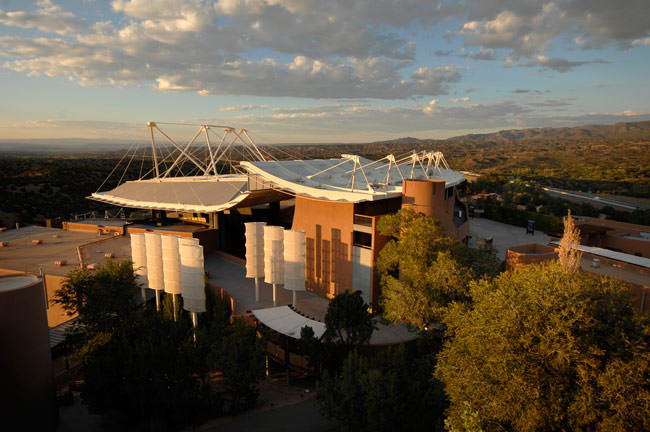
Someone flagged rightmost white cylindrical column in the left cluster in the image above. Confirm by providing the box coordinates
[179,244,205,312]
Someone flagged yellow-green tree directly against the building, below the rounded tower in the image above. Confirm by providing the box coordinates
[377,208,476,330]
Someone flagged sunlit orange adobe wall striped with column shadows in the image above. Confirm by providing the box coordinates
[291,196,354,298]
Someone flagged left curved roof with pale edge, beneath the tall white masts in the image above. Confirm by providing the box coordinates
[90,175,248,213]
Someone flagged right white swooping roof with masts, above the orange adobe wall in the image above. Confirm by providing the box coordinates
[240,155,465,202]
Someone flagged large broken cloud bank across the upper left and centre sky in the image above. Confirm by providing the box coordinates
[0,0,461,99]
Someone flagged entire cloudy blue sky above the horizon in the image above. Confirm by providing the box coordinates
[0,0,650,143]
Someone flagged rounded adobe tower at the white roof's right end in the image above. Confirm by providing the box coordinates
[402,179,469,241]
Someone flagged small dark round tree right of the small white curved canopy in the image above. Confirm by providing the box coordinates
[325,291,375,347]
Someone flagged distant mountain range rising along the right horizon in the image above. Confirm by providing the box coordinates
[373,120,650,144]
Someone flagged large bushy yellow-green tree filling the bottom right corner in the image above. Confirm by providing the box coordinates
[435,263,650,431]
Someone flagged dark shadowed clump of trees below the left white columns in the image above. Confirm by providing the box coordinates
[54,261,265,431]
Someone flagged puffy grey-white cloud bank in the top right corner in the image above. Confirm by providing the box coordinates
[455,0,650,58]
